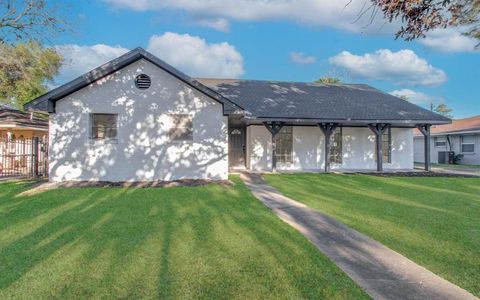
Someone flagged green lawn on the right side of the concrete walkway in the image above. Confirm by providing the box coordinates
[265,174,480,296]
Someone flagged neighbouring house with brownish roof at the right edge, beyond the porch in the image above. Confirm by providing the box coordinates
[414,116,480,165]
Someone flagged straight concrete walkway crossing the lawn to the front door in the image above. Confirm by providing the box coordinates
[241,173,477,299]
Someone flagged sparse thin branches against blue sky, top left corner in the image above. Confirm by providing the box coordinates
[0,0,67,43]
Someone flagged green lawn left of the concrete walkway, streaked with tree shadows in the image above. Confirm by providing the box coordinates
[0,177,367,299]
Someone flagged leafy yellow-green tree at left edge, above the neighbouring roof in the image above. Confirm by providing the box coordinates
[0,41,62,109]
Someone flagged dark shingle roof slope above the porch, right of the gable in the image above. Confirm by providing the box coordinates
[197,79,450,123]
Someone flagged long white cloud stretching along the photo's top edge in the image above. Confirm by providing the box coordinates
[104,0,392,32]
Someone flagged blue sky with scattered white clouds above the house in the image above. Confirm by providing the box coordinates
[51,0,480,118]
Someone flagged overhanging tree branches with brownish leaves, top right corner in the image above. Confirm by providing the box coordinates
[361,0,480,41]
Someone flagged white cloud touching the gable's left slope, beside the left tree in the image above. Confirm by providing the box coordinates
[55,44,128,83]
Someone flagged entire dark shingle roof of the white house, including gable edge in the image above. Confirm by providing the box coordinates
[25,48,450,124]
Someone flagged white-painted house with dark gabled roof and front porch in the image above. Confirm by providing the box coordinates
[25,48,450,181]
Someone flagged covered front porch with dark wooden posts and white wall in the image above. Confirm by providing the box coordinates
[229,116,431,172]
